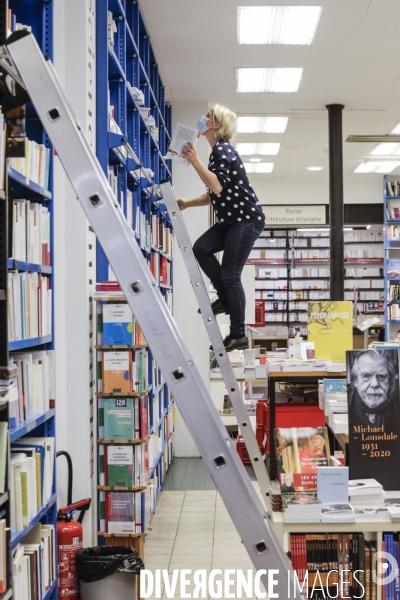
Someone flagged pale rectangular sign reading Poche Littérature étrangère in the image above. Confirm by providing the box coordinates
[263,204,326,226]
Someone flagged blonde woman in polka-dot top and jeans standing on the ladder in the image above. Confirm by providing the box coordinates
[178,104,265,352]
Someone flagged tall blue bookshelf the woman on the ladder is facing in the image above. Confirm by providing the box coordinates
[94,0,174,557]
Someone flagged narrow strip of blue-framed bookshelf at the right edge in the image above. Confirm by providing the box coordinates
[383,176,400,341]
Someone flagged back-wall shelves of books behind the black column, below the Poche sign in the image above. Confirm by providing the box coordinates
[248,226,384,336]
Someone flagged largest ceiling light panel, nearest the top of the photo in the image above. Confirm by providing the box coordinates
[237,6,322,45]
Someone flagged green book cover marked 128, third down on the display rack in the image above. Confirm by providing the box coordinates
[104,398,134,440]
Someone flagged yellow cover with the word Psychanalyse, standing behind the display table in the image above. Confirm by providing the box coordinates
[307,300,353,361]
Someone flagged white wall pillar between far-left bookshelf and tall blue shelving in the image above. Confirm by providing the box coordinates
[54,0,96,545]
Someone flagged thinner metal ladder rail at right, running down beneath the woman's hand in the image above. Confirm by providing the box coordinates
[160,181,270,510]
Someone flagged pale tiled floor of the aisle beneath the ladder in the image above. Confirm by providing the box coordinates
[145,459,266,598]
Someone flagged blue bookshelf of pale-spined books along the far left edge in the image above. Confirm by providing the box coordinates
[0,0,58,600]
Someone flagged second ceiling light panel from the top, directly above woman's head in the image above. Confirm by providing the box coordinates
[236,67,303,93]
